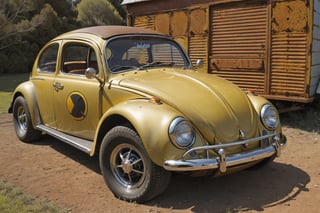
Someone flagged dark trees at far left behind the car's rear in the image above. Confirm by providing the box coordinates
[0,0,79,73]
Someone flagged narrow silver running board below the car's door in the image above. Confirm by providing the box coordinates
[37,124,92,154]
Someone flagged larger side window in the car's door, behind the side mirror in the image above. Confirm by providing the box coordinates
[62,43,98,75]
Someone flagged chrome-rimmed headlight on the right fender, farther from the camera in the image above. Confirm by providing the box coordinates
[260,104,279,130]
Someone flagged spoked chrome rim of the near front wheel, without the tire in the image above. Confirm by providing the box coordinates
[110,144,146,189]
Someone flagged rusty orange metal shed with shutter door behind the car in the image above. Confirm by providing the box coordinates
[123,0,320,103]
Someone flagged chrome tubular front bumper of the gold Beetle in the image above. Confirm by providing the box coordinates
[163,133,286,172]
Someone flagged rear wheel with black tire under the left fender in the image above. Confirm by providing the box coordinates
[13,96,41,143]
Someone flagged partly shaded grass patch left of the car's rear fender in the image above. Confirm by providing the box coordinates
[0,73,29,113]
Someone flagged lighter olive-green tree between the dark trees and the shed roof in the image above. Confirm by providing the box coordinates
[77,0,125,26]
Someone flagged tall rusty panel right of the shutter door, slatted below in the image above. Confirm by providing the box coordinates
[270,0,309,97]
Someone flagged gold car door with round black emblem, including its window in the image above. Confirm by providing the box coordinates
[54,42,100,140]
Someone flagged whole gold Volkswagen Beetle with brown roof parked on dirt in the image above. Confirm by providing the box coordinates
[9,26,286,202]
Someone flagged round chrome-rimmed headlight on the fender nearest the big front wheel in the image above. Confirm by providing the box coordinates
[169,117,195,149]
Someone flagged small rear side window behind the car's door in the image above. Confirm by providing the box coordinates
[38,44,59,73]
